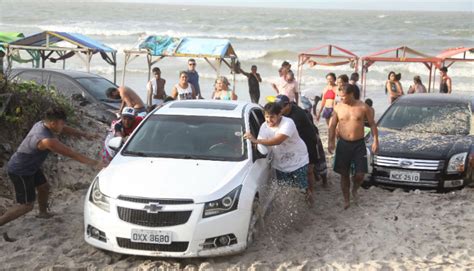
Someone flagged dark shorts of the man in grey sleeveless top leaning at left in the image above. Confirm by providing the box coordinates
[8,169,46,204]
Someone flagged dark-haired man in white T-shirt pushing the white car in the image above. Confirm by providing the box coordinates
[244,102,312,203]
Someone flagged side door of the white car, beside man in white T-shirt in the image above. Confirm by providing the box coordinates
[244,108,271,206]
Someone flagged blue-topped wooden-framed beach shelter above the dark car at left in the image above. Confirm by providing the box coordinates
[5,31,117,82]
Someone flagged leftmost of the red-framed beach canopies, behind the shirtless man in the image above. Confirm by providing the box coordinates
[296,44,359,97]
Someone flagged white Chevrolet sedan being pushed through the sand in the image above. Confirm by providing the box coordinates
[84,100,272,257]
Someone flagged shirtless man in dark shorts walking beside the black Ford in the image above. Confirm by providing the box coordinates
[328,84,379,209]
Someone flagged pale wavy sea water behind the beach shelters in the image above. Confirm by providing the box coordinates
[0,1,474,118]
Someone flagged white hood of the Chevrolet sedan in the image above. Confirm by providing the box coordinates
[99,155,248,202]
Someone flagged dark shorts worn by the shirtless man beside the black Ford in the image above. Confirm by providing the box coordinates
[334,138,368,176]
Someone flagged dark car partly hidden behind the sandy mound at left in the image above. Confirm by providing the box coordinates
[10,68,121,121]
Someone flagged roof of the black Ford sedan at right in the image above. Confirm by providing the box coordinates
[397,93,474,108]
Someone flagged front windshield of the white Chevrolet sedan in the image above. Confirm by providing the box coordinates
[122,115,246,161]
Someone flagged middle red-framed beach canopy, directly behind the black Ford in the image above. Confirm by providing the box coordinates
[361,46,440,97]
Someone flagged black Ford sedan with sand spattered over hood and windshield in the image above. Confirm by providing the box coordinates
[369,94,474,191]
